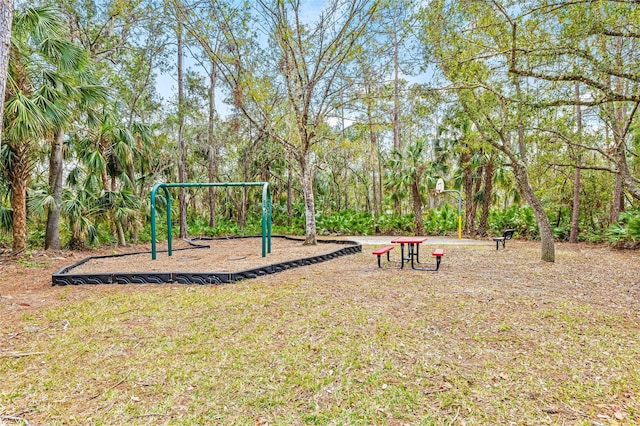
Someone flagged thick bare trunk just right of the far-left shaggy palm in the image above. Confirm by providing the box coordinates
[44,131,64,250]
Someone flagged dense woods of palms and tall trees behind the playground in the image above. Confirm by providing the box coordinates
[0,0,640,262]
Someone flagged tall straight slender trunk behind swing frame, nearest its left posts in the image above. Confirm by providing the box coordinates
[176,22,187,238]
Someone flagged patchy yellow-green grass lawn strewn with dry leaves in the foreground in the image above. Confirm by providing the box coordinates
[0,242,640,425]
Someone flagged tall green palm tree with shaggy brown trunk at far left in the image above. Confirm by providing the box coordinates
[3,6,87,253]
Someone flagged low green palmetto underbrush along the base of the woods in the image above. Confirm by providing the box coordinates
[7,204,640,248]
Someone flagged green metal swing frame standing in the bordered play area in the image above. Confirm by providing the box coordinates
[151,182,271,260]
